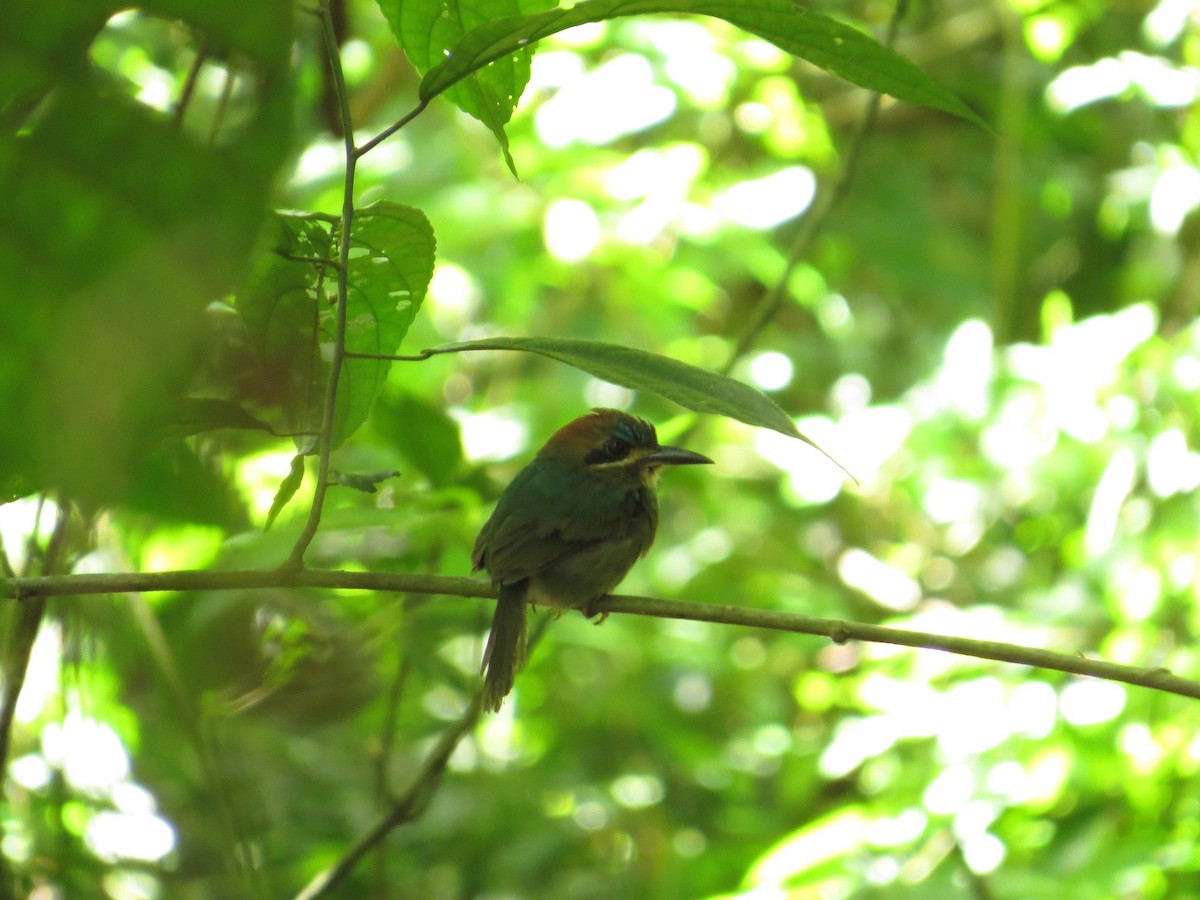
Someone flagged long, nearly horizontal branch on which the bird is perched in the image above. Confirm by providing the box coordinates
[7,569,1200,700]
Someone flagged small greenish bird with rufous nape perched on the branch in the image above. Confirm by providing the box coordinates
[472,409,713,710]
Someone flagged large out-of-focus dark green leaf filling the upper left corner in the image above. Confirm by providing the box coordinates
[0,0,292,503]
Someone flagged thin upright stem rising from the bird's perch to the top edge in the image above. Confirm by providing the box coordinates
[284,0,358,569]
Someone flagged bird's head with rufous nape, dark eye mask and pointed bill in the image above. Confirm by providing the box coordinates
[538,409,713,486]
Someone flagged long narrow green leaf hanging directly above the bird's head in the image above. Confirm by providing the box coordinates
[425,337,850,475]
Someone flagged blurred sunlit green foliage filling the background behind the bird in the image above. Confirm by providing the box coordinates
[0,0,1200,900]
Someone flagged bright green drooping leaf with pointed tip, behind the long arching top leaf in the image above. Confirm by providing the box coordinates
[378,0,554,175]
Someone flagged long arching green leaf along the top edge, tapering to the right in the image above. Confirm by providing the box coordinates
[420,0,983,125]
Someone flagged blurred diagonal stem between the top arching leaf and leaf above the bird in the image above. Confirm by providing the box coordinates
[720,0,908,374]
